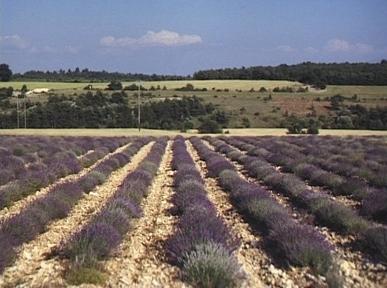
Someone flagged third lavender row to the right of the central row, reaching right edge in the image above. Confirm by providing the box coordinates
[229,138,387,223]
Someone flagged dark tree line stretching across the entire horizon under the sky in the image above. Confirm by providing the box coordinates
[4,60,387,88]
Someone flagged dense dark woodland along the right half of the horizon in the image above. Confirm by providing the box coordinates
[193,60,387,88]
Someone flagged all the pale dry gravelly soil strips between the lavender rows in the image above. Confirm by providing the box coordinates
[0,141,387,287]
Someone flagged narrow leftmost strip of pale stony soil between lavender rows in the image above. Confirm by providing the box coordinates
[0,143,131,223]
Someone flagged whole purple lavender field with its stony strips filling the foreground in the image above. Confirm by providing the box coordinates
[0,136,387,287]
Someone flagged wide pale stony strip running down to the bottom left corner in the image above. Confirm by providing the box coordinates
[0,142,154,287]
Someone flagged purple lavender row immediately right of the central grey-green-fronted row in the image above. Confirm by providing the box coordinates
[191,138,332,274]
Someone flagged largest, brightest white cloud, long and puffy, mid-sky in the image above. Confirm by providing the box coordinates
[100,30,202,48]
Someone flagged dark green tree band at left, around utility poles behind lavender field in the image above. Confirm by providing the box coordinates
[0,91,228,129]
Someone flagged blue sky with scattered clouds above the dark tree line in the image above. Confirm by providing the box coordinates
[0,0,387,75]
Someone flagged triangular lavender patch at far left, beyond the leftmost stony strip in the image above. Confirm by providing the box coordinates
[0,137,128,209]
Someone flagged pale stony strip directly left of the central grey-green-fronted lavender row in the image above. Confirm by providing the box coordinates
[105,142,187,287]
